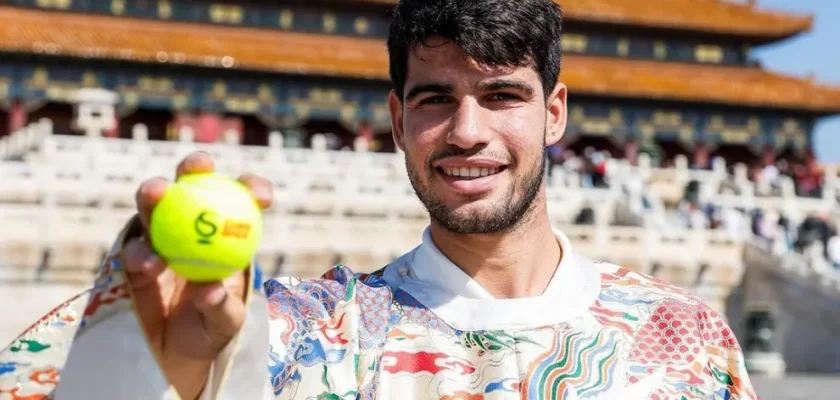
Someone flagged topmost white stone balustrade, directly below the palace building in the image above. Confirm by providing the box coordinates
[2,121,839,221]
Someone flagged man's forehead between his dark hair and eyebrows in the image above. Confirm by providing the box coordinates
[406,38,541,88]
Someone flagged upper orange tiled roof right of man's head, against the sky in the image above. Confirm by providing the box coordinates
[352,0,813,42]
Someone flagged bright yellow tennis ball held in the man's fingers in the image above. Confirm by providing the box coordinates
[149,174,262,282]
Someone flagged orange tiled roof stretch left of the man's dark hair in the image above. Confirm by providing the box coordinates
[0,6,385,78]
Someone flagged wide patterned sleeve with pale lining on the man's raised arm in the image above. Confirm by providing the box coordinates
[0,217,274,400]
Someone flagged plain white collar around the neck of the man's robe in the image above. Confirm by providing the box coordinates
[383,228,601,331]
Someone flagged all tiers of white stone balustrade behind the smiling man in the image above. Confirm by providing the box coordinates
[0,121,836,296]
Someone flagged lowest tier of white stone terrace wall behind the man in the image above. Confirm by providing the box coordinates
[0,201,741,285]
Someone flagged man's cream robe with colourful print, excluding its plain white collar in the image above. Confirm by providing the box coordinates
[0,230,757,400]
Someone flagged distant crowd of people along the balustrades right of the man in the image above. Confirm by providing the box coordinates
[548,146,840,271]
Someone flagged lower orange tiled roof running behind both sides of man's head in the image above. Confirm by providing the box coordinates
[0,6,840,113]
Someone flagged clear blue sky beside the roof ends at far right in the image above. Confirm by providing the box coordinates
[753,0,840,164]
